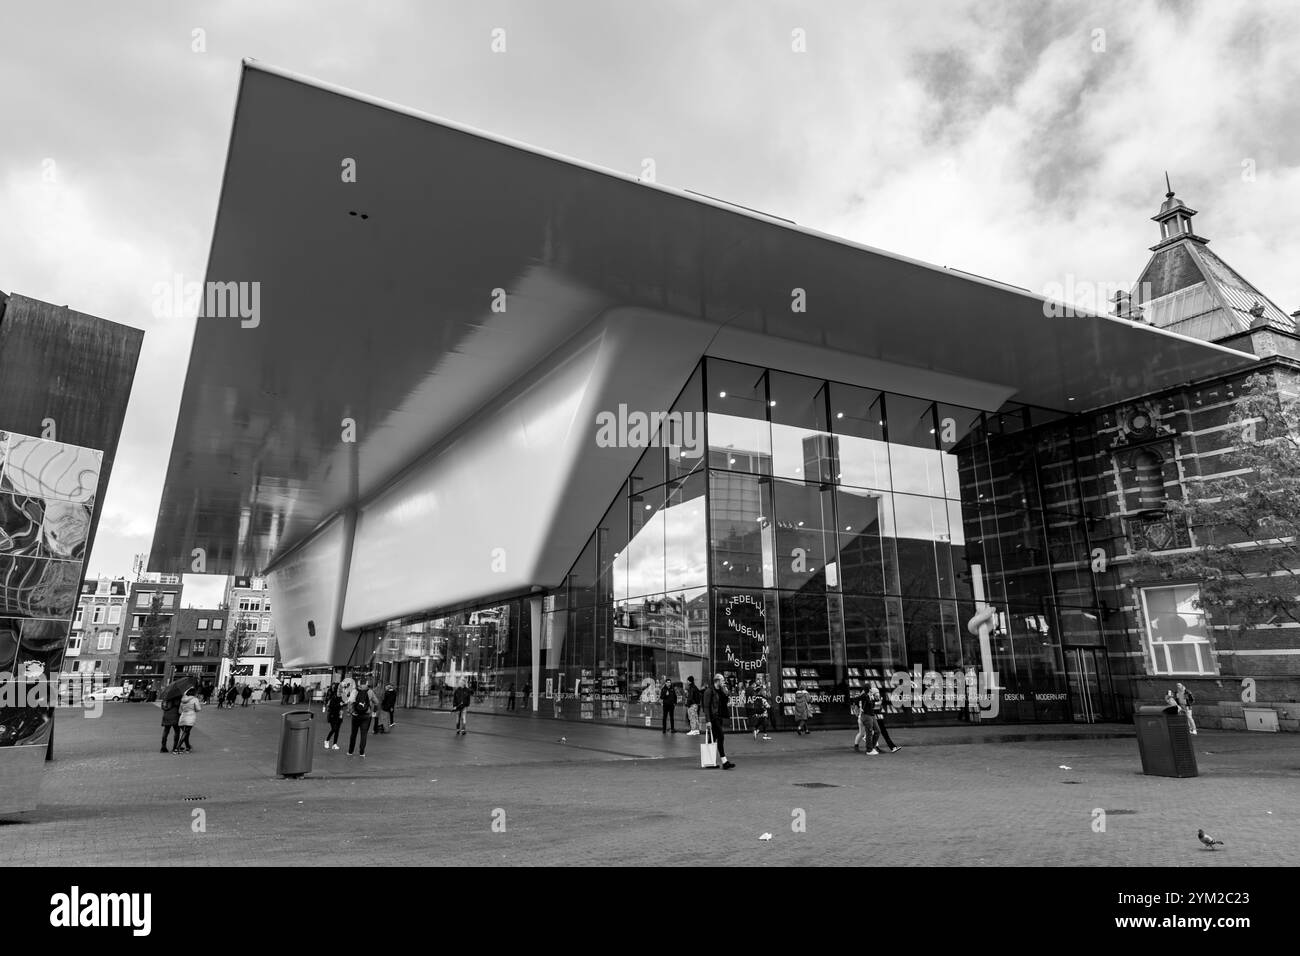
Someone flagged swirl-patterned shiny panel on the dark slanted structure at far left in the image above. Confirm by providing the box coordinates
[0,431,103,747]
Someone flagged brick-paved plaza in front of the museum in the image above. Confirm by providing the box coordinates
[0,704,1300,866]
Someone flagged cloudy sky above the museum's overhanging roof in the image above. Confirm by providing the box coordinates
[0,0,1300,598]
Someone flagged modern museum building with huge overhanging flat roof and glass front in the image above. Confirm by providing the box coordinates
[150,62,1251,727]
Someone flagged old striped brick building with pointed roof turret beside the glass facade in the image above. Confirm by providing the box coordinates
[965,183,1300,731]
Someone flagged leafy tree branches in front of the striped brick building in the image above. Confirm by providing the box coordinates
[1138,375,1300,628]
